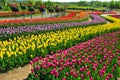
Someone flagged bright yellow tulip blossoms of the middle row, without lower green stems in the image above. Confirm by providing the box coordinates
[0,16,120,58]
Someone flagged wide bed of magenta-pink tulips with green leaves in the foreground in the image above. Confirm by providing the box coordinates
[28,31,120,80]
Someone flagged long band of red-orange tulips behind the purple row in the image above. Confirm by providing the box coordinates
[0,12,88,27]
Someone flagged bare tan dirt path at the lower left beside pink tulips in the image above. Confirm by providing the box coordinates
[0,65,31,80]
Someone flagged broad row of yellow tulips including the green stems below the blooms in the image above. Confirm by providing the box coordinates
[0,15,120,72]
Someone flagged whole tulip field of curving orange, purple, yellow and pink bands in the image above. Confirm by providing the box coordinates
[0,10,120,80]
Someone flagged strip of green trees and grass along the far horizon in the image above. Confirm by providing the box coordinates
[0,0,120,10]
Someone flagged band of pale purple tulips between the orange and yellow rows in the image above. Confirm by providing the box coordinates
[0,13,106,40]
